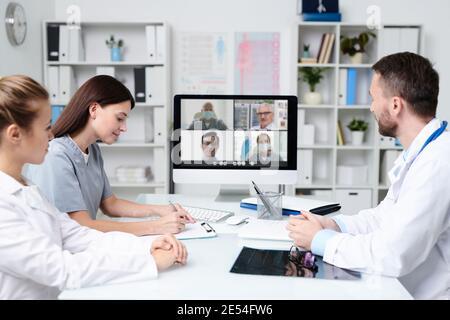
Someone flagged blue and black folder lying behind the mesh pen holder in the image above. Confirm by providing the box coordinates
[240,196,341,216]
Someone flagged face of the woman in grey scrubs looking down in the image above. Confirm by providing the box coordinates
[91,101,131,144]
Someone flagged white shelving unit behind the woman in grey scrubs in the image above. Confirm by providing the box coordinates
[42,21,171,200]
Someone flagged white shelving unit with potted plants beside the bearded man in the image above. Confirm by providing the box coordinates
[287,22,422,214]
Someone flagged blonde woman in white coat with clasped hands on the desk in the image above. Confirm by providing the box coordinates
[0,76,187,299]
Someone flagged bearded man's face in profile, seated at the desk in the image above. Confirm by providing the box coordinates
[369,73,397,137]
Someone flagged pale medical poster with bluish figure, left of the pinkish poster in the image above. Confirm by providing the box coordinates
[177,32,228,94]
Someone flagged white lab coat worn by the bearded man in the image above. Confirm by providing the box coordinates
[324,119,450,299]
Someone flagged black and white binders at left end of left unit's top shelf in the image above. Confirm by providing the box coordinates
[47,23,85,62]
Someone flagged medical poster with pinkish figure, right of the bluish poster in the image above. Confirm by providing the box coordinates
[234,32,280,95]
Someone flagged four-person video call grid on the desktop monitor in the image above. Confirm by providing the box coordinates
[175,97,296,169]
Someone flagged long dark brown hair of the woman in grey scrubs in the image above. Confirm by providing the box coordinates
[52,75,134,138]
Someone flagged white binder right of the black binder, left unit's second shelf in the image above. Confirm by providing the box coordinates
[143,66,165,105]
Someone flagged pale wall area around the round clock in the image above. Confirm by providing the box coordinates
[0,0,55,83]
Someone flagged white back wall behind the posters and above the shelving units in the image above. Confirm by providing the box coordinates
[51,0,450,194]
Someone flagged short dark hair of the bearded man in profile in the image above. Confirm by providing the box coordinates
[372,52,439,118]
